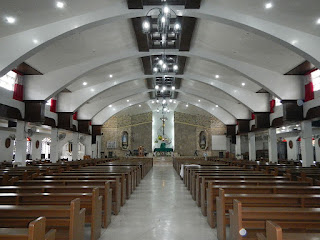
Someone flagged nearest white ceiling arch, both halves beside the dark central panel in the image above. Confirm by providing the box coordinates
[0,1,320,79]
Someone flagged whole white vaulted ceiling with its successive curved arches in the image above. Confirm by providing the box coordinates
[0,0,320,124]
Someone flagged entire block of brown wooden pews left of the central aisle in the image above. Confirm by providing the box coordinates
[0,158,153,240]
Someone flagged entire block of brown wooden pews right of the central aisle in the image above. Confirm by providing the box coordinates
[173,158,320,240]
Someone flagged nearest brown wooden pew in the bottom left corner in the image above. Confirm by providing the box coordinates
[0,217,56,240]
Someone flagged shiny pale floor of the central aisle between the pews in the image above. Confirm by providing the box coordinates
[100,163,217,240]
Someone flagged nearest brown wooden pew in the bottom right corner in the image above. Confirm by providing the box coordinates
[257,221,320,240]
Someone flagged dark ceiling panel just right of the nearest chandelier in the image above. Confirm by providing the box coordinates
[179,17,197,51]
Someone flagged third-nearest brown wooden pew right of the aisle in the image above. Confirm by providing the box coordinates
[216,189,320,240]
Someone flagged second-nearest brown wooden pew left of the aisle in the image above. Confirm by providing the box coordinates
[0,199,86,240]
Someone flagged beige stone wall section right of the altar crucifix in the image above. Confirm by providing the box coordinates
[174,112,227,156]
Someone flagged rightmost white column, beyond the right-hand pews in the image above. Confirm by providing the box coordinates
[301,121,313,167]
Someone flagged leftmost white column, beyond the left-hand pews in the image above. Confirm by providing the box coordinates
[15,121,27,166]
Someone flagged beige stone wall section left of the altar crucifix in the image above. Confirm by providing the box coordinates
[101,112,152,157]
